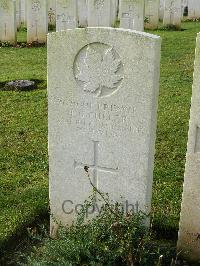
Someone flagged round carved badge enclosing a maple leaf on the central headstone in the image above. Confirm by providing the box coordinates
[74,43,124,97]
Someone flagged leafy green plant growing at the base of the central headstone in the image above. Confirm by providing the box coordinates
[28,188,177,266]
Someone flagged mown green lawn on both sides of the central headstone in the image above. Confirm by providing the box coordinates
[0,22,200,252]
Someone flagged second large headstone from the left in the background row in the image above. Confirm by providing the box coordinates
[27,0,48,43]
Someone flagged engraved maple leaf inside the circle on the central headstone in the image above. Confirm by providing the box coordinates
[76,46,122,96]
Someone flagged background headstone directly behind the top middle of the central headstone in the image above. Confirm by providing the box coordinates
[87,0,112,27]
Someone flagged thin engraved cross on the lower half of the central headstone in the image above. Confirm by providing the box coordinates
[74,141,118,189]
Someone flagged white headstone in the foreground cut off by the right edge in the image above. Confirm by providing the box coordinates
[178,34,200,262]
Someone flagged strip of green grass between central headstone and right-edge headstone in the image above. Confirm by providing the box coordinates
[149,23,200,232]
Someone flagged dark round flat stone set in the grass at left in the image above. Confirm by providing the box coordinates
[3,80,37,91]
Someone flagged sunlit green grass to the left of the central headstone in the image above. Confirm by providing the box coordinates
[0,39,48,246]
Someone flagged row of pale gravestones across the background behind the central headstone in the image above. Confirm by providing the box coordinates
[0,0,195,43]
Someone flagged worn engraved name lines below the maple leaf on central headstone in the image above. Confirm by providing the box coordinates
[53,98,144,137]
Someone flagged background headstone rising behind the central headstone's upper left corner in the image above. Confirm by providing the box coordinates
[56,0,78,31]
